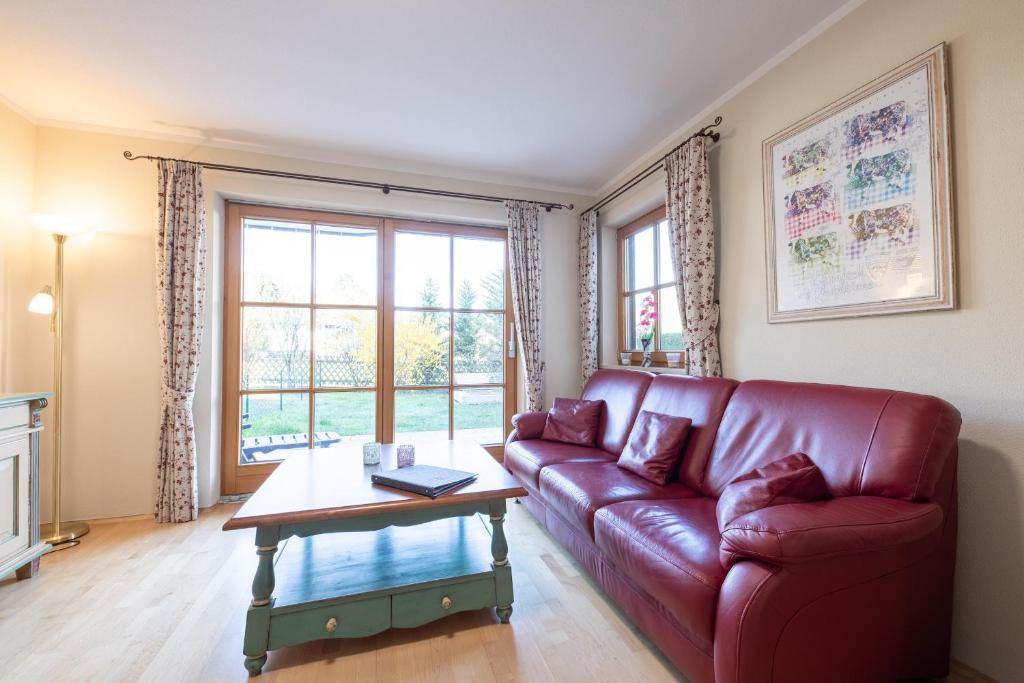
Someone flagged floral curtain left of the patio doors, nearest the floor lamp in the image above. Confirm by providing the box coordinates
[154,161,206,522]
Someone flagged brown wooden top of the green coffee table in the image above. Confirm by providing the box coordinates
[223,440,526,531]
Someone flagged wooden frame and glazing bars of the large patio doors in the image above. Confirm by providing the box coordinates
[220,201,518,495]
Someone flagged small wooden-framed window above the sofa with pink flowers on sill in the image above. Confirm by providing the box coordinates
[618,207,683,364]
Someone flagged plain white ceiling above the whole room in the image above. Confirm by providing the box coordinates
[0,0,845,191]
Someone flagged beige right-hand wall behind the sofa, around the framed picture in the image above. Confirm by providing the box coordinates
[602,0,1024,681]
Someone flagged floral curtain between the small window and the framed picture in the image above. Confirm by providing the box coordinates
[665,135,722,377]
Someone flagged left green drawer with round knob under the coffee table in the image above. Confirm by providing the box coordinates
[268,595,391,650]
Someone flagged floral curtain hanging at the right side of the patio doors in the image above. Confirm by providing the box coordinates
[505,200,544,411]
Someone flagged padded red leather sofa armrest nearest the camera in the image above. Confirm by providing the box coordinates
[720,496,943,566]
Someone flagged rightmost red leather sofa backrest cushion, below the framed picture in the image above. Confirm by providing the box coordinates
[696,381,961,500]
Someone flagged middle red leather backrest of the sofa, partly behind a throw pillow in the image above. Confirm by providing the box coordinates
[640,375,739,488]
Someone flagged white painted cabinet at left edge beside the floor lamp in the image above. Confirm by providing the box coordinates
[0,393,49,579]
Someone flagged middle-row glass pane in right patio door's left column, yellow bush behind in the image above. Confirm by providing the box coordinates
[394,310,451,387]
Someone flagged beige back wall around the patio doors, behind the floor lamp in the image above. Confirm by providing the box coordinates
[0,122,590,519]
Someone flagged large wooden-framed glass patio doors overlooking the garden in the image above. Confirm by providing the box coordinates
[222,203,515,494]
